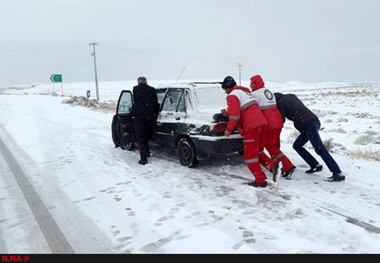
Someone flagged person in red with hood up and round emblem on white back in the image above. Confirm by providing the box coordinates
[250,75,296,179]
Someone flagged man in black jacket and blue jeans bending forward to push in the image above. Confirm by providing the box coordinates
[274,92,345,182]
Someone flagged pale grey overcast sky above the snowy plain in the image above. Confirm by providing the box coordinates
[0,0,380,85]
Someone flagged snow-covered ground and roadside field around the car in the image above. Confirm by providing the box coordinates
[0,80,380,254]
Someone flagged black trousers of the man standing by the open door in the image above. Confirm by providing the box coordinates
[133,114,155,162]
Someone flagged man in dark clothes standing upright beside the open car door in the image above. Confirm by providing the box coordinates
[132,77,159,165]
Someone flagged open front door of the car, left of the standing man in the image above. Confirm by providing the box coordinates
[112,90,135,150]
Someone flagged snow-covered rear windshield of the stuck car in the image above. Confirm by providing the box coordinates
[195,86,227,109]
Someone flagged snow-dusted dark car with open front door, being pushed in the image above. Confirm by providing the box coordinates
[112,82,244,167]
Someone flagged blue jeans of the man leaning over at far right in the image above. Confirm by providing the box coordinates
[293,119,341,175]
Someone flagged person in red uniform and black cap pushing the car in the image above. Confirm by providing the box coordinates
[221,76,276,187]
